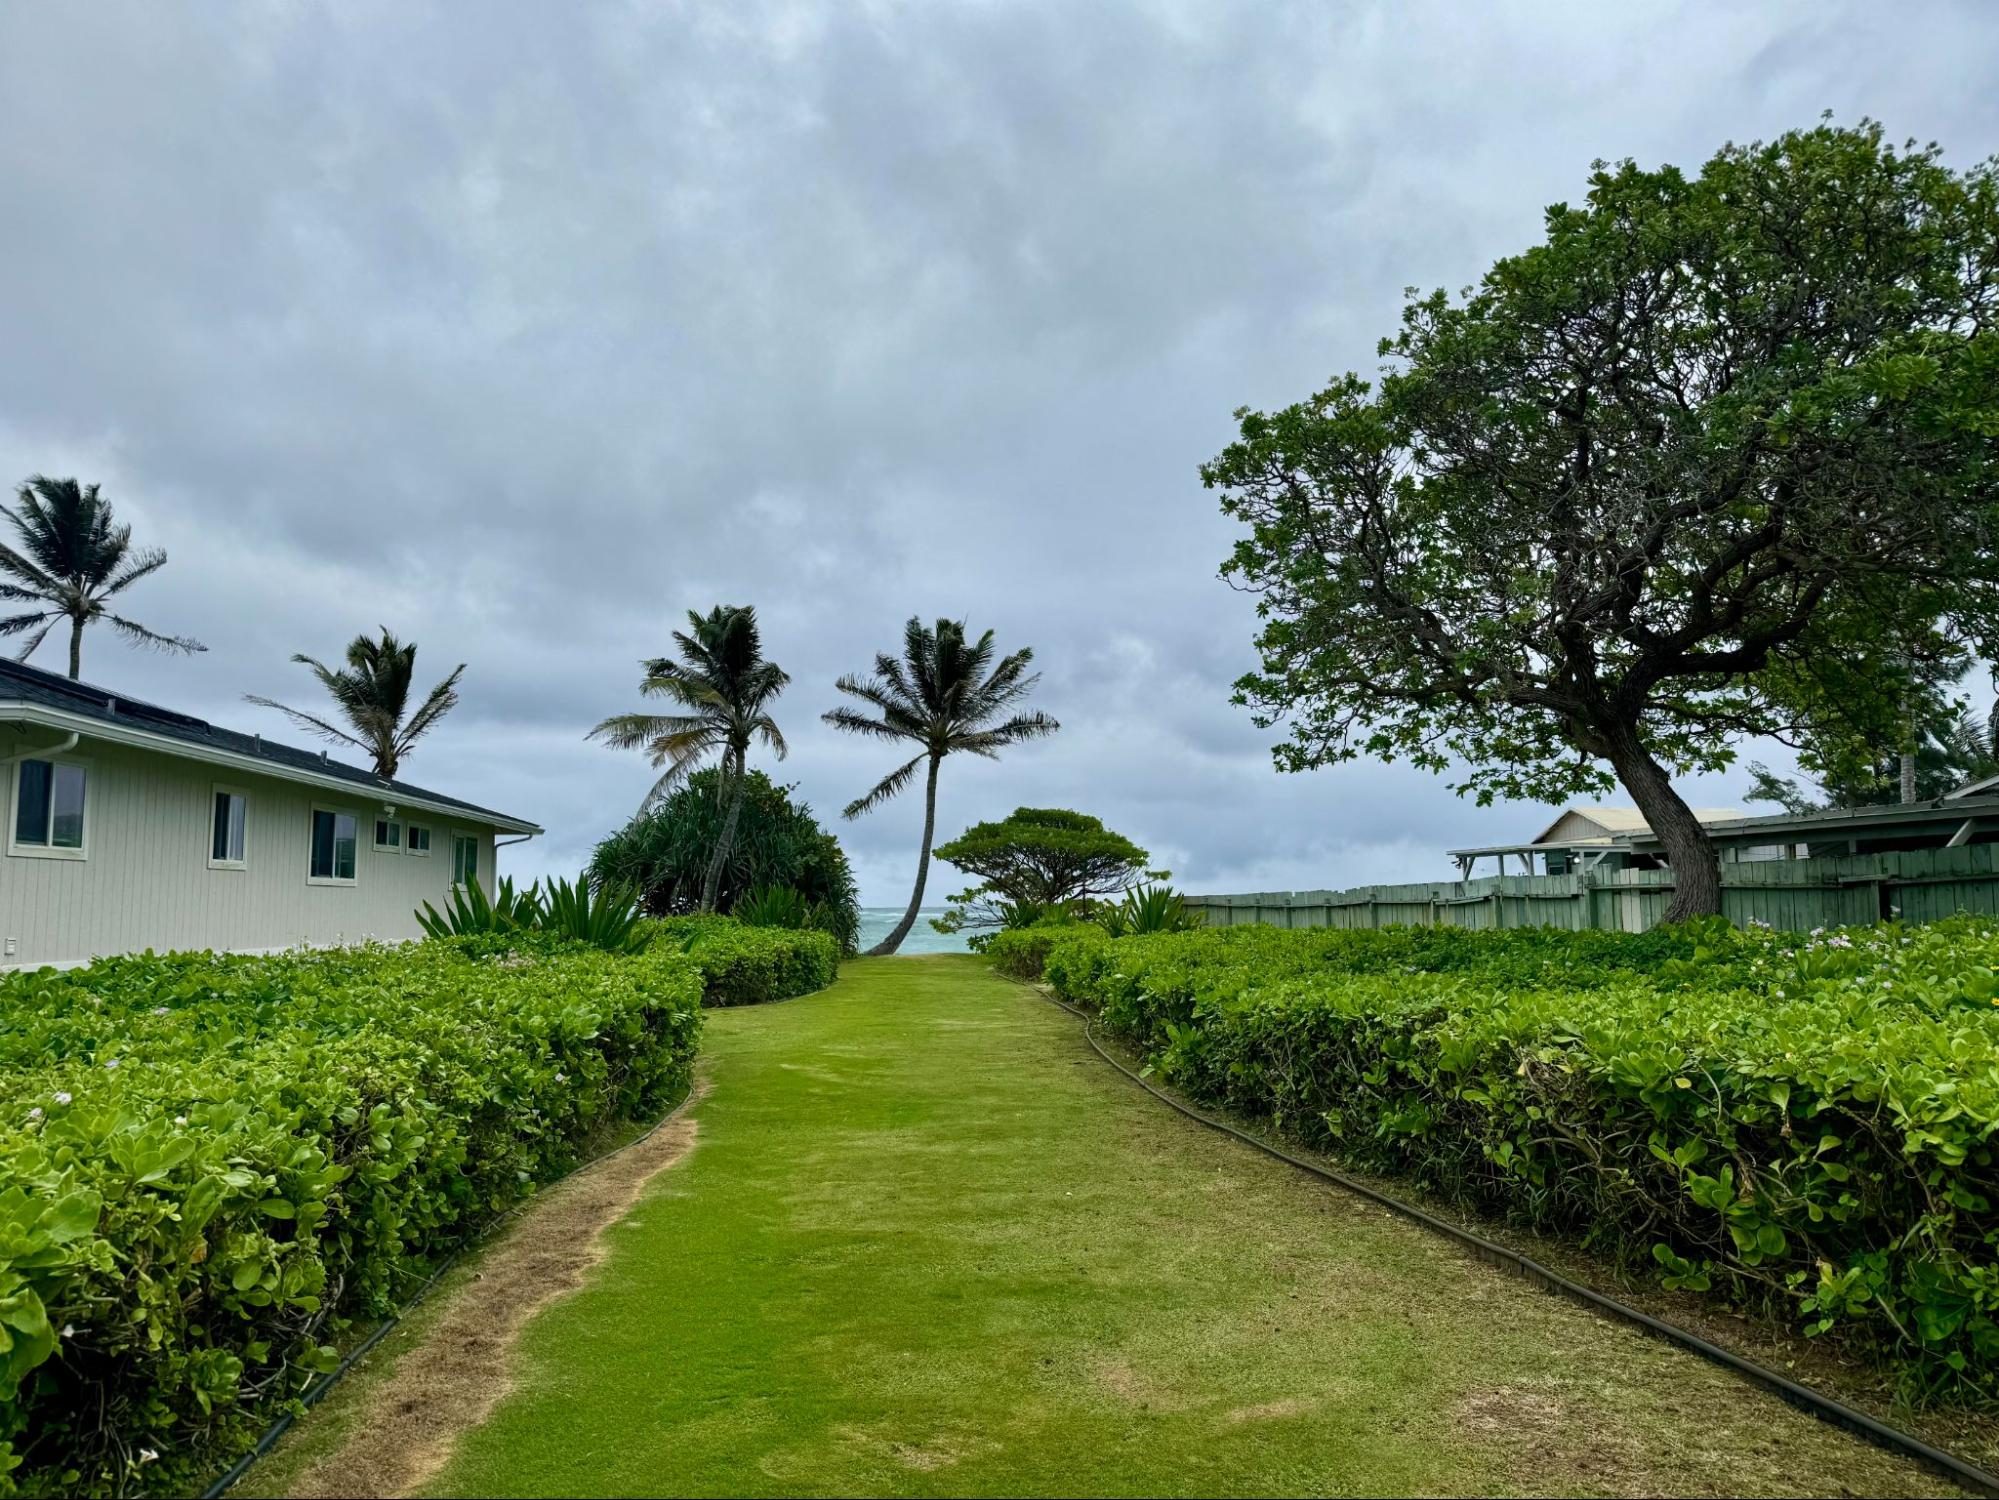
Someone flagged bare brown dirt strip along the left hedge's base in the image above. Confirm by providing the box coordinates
[286,1084,706,1498]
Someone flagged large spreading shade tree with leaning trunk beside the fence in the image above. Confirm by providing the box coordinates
[1201,124,1999,920]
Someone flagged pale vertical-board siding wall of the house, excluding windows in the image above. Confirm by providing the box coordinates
[0,738,496,968]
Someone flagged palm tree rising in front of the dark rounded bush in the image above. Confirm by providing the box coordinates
[590,604,792,912]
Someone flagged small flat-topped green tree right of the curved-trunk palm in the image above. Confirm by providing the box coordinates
[932,808,1147,932]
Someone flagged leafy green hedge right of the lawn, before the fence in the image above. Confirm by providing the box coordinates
[1045,918,1999,1396]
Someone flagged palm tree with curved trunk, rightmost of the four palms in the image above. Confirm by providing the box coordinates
[826,616,1061,958]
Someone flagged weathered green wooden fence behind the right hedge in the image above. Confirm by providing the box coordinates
[1187,844,1999,932]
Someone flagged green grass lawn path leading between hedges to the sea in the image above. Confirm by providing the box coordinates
[430,956,1939,1496]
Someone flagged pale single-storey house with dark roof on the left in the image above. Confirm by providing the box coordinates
[0,662,542,968]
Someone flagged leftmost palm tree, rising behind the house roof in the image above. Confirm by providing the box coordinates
[0,474,208,680]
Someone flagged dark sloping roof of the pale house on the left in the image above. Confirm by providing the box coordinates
[0,660,542,834]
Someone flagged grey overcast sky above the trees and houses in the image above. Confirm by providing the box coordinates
[0,0,1999,904]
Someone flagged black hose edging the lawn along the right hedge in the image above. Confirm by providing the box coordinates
[1035,990,1999,1496]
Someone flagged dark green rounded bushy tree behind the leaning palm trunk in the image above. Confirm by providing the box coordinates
[590,766,862,952]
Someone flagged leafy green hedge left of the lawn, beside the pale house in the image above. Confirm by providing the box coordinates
[0,942,702,1494]
